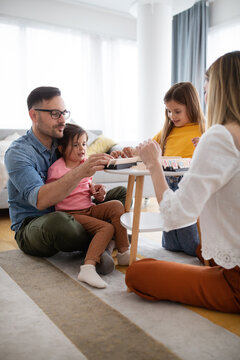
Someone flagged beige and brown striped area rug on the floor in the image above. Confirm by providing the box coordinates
[0,237,240,360]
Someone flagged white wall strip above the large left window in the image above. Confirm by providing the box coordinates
[0,0,136,40]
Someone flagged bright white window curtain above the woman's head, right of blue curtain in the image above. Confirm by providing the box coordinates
[207,18,240,67]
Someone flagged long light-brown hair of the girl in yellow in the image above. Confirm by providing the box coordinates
[160,82,205,154]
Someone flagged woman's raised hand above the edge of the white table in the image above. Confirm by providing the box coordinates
[137,139,162,169]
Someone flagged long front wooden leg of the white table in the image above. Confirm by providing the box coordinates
[129,176,144,265]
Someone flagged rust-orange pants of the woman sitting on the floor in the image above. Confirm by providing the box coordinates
[126,259,240,313]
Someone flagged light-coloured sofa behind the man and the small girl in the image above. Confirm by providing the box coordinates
[0,129,155,209]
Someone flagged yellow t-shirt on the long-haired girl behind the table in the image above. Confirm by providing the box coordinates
[153,123,202,158]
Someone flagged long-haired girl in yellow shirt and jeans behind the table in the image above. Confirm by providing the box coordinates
[111,82,205,256]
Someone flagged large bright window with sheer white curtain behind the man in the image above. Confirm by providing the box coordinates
[0,17,139,141]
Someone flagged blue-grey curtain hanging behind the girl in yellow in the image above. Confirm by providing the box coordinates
[172,0,208,109]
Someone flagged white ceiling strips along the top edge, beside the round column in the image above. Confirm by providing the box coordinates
[55,0,196,15]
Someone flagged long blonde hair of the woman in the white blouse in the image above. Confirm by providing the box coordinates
[207,51,240,127]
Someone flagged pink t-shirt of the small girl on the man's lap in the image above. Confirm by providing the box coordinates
[47,158,94,211]
